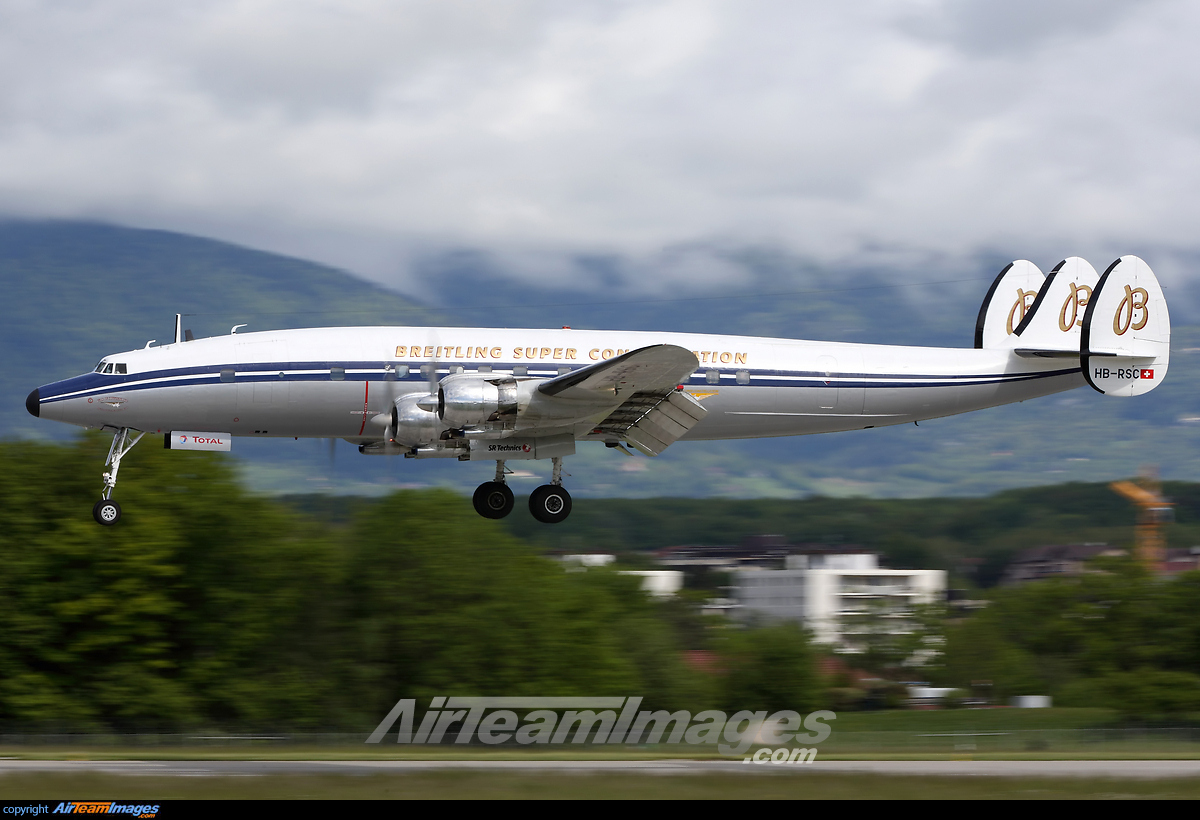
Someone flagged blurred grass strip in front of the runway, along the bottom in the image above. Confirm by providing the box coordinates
[0,772,1200,808]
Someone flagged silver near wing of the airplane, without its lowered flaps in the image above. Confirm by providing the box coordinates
[538,345,700,406]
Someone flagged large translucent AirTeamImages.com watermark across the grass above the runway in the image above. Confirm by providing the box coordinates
[367,698,838,764]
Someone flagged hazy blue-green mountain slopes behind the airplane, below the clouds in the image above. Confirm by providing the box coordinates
[0,221,1200,497]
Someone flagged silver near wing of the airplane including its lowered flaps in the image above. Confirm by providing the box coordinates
[538,345,708,455]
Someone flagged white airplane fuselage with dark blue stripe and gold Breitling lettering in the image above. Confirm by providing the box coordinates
[29,327,1085,443]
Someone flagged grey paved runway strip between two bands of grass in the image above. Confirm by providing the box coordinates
[0,759,1200,779]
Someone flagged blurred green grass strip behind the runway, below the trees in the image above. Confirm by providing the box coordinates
[0,708,1200,760]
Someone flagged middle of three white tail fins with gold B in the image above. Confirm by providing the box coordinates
[1013,256,1100,357]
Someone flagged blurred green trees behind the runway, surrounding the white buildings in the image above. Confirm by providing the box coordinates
[0,435,1200,732]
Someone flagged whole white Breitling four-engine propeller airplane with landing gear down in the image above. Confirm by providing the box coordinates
[25,256,1171,525]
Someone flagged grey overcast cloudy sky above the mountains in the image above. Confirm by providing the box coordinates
[0,0,1200,291]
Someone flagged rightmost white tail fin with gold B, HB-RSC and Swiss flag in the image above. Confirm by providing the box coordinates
[1080,256,1171,396]
